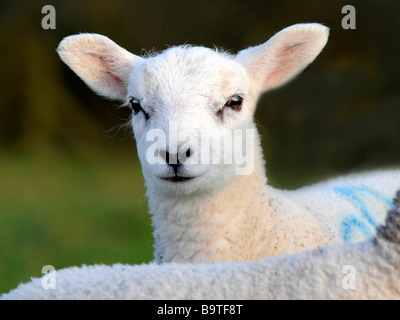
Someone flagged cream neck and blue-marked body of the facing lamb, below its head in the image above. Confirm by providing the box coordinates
[148,168,400,263]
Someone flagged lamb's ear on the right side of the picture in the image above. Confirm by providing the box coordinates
[236,23,329,94]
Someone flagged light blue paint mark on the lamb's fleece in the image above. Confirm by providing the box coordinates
[333,186,393,242]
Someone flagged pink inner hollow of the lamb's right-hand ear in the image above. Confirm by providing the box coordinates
[265,42,305,87]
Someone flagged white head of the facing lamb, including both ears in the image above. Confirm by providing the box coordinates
[58,24,328,195]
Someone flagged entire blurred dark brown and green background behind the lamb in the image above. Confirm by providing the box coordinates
[0,0,400,292]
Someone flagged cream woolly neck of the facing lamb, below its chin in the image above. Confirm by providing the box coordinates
[149,155,274,262]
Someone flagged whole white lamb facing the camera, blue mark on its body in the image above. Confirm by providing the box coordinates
[57,23,400,262]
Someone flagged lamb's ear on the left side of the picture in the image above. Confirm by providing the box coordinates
[57,34,143,100]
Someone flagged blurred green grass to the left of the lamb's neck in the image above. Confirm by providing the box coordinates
[0,148,153,293]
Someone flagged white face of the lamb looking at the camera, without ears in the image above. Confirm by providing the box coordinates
[127,47,254,194]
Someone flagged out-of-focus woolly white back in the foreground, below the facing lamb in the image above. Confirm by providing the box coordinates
[0,192,400,300]
